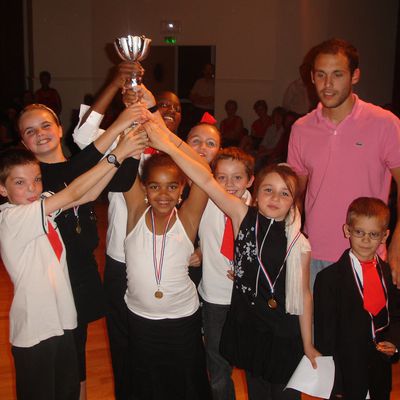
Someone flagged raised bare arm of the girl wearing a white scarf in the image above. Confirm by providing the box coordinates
[144,121,247,235]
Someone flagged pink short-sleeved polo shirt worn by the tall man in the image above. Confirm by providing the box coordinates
[288,95,400,262]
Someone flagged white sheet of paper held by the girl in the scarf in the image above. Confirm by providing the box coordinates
[286,356,335,399]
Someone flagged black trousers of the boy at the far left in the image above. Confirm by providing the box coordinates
[11,331,80,400]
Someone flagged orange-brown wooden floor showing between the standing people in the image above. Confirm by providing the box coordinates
[0,203,400,400]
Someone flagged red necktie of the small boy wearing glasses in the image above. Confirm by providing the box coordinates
[360,260,386,316]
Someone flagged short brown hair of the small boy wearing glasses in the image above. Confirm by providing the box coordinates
[346,197,390,229]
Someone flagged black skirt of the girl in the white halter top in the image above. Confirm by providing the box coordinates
[129,310,212,400]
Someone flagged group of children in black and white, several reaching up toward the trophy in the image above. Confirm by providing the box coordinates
[0,83,399,400]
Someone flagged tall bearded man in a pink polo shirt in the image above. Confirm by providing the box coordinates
[288,39,400,288]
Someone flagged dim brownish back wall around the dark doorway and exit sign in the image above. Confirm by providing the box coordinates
[29,0,398,130]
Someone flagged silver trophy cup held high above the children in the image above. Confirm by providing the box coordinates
[114,35,151,90]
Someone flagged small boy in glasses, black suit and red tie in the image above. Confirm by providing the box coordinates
[314,197,400,400]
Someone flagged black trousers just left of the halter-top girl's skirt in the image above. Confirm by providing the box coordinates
[104,255,134,400]
